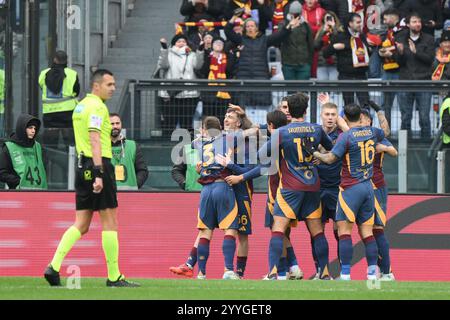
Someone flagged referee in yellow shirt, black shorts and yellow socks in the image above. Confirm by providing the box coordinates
[44,69,139,287]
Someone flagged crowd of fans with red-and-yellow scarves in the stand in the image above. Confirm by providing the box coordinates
[155,0,450,138]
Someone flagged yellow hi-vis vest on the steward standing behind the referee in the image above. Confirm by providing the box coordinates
[39,68,78,114]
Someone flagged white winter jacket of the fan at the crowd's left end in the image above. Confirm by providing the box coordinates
[158,47,204,99]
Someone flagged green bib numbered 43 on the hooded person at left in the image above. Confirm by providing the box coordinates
[5,141,47,190]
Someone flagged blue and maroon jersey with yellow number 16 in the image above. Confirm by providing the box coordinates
[331,127,384,189]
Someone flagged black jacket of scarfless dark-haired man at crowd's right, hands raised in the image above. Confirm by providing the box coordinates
[394,32,435,80]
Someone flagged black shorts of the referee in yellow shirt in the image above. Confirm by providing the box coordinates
[75,157,117,211]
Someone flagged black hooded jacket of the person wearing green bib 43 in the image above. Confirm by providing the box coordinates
[0,114,41,189]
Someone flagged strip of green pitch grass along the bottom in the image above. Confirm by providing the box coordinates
[0,277,450,300]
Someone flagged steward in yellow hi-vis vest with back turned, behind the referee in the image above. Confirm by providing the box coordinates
[39,51,80,147]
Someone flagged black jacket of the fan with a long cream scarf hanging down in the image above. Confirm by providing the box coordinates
[323,29,370,76]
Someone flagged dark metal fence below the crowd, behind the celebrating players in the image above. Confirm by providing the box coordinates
[119,80,450,141]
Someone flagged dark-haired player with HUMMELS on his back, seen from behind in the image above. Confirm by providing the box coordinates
[262,93,332,279]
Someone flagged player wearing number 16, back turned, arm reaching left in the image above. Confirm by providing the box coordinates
[303,104,384,280]
